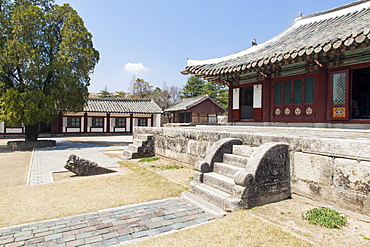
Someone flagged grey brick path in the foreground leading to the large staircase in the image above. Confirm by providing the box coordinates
[0,198,215,247]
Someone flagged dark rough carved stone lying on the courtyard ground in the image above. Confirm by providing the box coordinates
[64,154,117,176]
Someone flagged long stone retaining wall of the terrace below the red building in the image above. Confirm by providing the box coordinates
[134,127,370,215]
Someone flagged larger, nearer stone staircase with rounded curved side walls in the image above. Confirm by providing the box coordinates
[183,139,290,215]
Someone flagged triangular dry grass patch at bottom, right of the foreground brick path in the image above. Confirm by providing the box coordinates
[129,210,313,247]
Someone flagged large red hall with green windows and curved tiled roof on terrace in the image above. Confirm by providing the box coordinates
[181,0,370,127]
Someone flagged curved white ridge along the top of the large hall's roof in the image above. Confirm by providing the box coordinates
[187,0,370,66]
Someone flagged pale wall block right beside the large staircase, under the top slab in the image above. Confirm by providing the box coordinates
[292,152,334,186]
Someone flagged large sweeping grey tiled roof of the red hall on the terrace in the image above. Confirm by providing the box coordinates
[181,0,370,77]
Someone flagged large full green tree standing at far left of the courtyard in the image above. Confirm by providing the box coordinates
[0,0,99,141]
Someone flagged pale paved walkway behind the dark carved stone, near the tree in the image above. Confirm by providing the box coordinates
[27,138,123,185]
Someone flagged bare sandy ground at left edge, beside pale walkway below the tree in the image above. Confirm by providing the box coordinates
[0,139,32,187]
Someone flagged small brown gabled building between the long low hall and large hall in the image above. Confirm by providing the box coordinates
[164,95,225,124]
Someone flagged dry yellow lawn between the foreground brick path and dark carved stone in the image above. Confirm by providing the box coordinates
[0,161,186,227]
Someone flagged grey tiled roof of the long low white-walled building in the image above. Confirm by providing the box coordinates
[83,98,162,114]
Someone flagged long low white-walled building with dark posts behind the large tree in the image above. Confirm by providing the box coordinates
[0,98,162,134]
